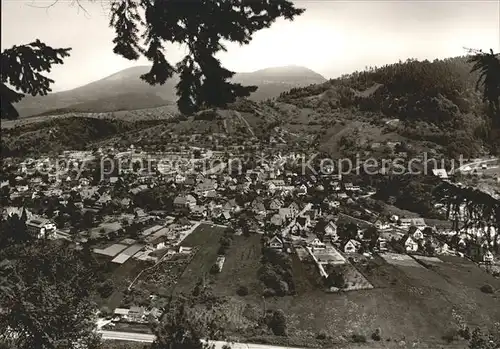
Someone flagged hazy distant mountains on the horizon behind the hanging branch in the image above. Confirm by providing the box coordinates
[16,66,326,117]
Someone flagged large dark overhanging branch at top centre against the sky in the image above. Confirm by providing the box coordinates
[110,0,304,114]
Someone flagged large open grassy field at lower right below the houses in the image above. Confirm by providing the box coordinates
[213,247,500,348]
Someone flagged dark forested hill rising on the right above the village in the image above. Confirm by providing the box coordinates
[278,56,498,155]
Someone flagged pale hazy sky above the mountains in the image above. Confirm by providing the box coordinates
[1,0,500,91]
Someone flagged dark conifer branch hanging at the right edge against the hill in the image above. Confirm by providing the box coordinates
[468,50,500,125]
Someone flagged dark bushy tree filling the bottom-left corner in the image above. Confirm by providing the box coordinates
[0,240,100,349]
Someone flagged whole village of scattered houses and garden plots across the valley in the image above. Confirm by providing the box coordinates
[1,134,500,342]
